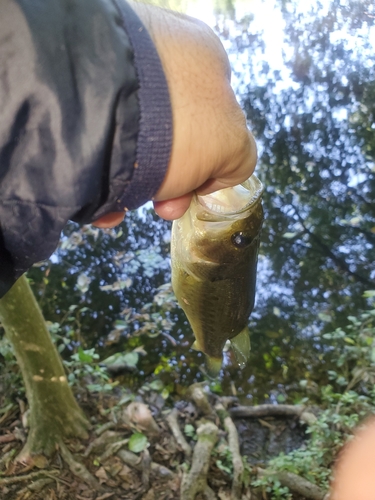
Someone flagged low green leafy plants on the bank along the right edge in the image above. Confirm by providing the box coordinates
[253,302,375,499]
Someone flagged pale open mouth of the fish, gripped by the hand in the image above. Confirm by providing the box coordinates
[196,175,264,222]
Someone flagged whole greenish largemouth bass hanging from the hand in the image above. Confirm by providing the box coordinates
[171,175,263,376]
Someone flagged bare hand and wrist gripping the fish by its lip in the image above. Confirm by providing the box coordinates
[129,2,257,219]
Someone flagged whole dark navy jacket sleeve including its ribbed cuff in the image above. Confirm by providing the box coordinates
[0,0,172,297]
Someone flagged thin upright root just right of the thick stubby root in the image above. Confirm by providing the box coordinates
[215,403,244,500]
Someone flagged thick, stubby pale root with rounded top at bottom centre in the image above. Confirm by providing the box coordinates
[181,422,219,500]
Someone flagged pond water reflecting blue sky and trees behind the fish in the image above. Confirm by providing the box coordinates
[30,0,375,403]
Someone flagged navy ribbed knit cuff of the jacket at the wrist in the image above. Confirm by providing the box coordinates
[115,0,173,211]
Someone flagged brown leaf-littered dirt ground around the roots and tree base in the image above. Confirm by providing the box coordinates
[0,386,304,500]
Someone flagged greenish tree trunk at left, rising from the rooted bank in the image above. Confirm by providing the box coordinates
[0,275,89,461]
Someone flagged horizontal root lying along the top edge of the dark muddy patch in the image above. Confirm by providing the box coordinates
[229,405,316,424]
